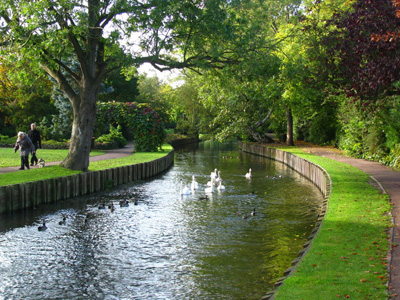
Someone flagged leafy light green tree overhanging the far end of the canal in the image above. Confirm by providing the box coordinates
[196,55,280,142]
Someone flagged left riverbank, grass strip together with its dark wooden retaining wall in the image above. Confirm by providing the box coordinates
[0,145,174,213]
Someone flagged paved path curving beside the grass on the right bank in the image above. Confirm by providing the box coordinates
[296,144,400,300]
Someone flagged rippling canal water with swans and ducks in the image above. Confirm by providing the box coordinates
[0,142,322,300]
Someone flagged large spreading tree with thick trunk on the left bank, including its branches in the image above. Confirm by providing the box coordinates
[0,0,240,170]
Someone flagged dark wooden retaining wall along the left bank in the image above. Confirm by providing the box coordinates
[0,151,174,214]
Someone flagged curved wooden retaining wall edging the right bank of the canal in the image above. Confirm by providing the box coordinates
[239,142,332,300]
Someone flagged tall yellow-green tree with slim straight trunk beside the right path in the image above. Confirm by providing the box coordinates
[275,0,348,145]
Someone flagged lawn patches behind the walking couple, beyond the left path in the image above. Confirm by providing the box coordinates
[0,148,105,168]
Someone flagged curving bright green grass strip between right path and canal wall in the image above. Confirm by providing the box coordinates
[274,148,392,300]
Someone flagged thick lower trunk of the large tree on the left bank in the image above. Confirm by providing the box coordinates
[61,84,98,171]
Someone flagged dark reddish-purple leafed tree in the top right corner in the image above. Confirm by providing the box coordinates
[327,0,400,99]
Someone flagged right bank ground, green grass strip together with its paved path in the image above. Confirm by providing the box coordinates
[274,144,400,300]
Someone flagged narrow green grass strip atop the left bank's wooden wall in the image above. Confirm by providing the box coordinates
[0,144,173,186]
